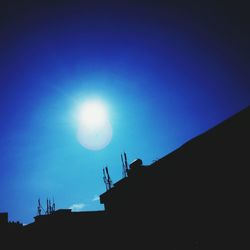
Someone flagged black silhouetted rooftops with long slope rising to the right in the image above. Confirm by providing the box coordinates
[0,104,250,250]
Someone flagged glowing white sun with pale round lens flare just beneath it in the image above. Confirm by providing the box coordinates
[77,100,112,150]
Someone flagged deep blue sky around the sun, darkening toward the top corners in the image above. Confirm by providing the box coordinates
[0,1,250,223]
